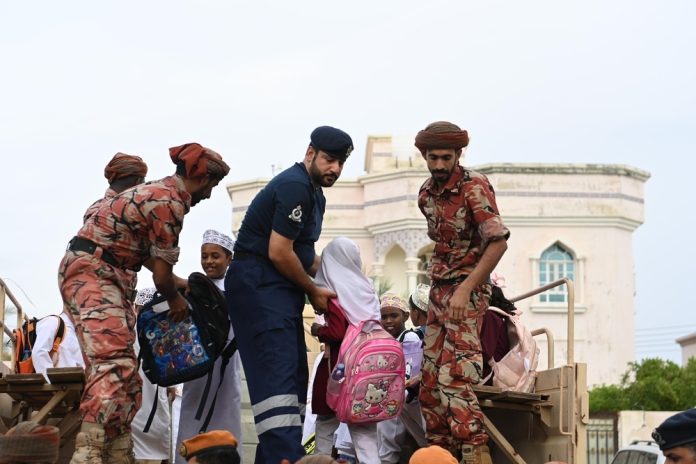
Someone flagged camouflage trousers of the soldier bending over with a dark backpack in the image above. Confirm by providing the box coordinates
[58,250,142,439]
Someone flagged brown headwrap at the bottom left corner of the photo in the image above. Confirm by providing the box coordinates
[0,421,60,462]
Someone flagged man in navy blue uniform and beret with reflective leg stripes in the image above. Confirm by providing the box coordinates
[225,126,353,464]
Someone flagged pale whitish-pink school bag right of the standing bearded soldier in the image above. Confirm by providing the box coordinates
[482,306,539,393]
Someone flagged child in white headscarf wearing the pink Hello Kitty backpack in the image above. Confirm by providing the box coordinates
[312,237,380,464]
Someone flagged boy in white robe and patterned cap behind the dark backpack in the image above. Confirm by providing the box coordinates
[176,230,242,464]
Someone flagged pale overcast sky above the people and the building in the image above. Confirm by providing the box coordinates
[0,0,696,366]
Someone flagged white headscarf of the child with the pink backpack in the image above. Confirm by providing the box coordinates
[315,237,381,325]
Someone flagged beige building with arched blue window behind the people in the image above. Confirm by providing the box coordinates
[228,136,649,385]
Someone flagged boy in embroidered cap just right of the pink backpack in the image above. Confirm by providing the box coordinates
[377,293,426,463]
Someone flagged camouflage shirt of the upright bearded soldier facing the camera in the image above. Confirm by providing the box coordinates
[418,166,510,281]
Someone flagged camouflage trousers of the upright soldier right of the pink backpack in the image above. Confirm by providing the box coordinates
[419,282,491,451]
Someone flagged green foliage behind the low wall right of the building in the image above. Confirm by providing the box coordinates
[590,358,696,413]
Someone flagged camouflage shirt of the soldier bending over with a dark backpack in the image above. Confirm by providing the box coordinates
[77,176,191,269]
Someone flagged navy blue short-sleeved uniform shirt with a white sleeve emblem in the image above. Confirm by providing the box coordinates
[234,163,326,269]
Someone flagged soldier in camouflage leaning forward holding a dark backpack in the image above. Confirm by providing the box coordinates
[58,143,229,464]
